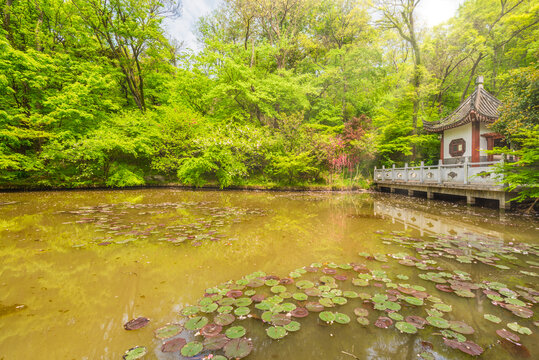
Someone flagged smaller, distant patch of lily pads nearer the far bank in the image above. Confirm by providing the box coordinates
[60,201,266,247]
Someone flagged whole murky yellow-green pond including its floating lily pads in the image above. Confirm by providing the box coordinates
[0,189,539,360]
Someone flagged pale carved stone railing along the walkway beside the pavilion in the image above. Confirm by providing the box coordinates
[374,159,504,185]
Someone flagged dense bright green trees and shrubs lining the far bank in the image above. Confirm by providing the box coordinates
[0,0,539,191]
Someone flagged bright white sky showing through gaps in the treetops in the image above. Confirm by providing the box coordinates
[165,0,464,50]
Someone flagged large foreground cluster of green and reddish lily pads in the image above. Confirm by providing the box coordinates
[124,231,539,360]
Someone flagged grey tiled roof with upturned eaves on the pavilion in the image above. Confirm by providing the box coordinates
[423,86,501,133]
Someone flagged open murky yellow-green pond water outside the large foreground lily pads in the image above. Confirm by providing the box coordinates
[0,189,539,360]
